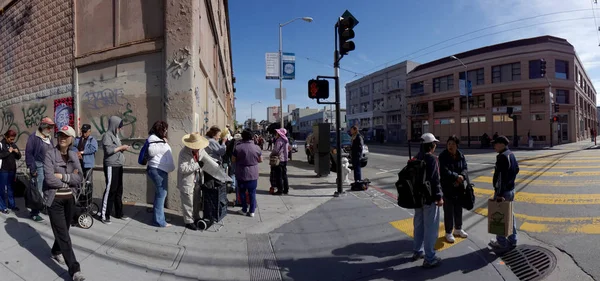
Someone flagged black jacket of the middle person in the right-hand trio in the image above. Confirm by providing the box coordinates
[439,150,467,198]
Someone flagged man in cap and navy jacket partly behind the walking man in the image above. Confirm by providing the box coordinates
[25,117,54,222]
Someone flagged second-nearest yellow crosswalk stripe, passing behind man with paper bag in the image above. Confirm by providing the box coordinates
[473,187,600,205]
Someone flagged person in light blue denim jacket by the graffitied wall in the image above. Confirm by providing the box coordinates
[71,124,98,182]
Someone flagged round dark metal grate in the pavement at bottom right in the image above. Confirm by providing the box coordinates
[502,245,556,281]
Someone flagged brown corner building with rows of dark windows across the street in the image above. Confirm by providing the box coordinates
[407,36,598,145]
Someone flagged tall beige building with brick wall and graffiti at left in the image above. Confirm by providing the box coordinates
[0,0,235,209]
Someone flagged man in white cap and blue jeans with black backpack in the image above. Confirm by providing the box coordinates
[412,133,444,268]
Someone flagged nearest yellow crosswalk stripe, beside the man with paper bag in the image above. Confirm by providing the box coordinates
[473,208,600,234]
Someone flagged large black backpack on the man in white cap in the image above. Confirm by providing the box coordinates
[396,159,431,209]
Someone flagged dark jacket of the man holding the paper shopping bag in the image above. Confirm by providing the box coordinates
[493,148,519,194]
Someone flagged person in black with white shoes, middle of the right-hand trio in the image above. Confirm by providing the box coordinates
[439,135,469,243]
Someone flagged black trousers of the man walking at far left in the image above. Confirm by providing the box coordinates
[48,196,81,276]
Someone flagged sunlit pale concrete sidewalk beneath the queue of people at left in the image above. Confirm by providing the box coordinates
[0,161,335,281]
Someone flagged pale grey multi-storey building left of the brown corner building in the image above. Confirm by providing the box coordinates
[346,61,418,142]
